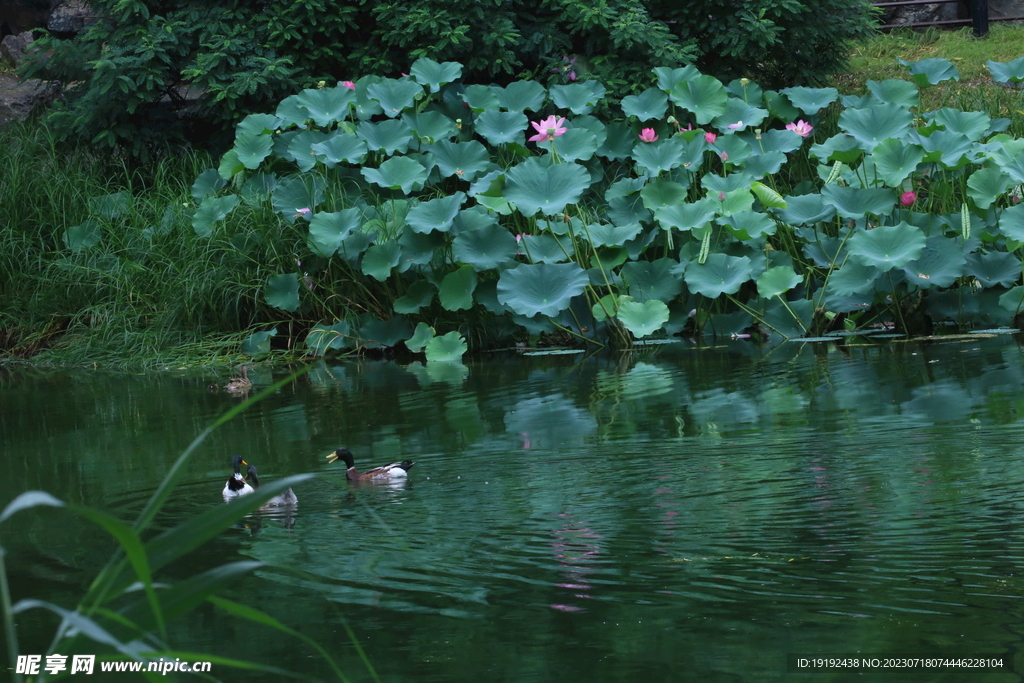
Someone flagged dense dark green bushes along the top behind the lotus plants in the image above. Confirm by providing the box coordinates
[22,0,868,155]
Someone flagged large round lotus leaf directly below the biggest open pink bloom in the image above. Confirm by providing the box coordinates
[504,157,591,217]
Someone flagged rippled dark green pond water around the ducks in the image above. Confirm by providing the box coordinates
[0,336,1024,683]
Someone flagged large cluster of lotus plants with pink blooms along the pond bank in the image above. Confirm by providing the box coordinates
[61,58,1024,359]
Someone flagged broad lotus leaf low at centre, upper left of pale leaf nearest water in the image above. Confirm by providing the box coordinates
[498,263,590,317]
